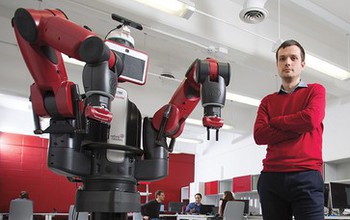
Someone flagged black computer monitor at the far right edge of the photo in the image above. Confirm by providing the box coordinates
[329,182,350,209]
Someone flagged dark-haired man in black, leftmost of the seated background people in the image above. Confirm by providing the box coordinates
[141,190,165,220]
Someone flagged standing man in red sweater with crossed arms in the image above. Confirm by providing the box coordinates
[254,40,326,220]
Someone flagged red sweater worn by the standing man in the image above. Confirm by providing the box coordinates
[254,83,326,172]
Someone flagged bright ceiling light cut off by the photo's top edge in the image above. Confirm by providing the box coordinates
[136,0,196,19]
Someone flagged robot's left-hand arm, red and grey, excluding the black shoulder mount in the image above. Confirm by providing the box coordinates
[12,8,117,133]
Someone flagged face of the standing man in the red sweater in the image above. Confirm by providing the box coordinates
[277,45,305,80]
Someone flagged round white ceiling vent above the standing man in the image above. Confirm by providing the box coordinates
[239,0,268,24]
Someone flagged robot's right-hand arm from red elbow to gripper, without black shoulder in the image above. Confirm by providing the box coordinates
[152,58,230,147]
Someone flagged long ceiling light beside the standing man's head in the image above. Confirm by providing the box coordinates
[305,54,350,80]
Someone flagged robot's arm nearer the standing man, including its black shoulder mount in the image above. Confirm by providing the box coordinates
[135,58,230,181]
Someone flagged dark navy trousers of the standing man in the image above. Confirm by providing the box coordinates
[258,170,324,220]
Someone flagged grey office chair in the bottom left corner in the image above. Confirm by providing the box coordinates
[9,199,33,220]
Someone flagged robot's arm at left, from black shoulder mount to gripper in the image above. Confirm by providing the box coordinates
[12,8,126,179]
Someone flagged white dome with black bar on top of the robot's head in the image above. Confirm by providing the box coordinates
[105,14,143,48]
